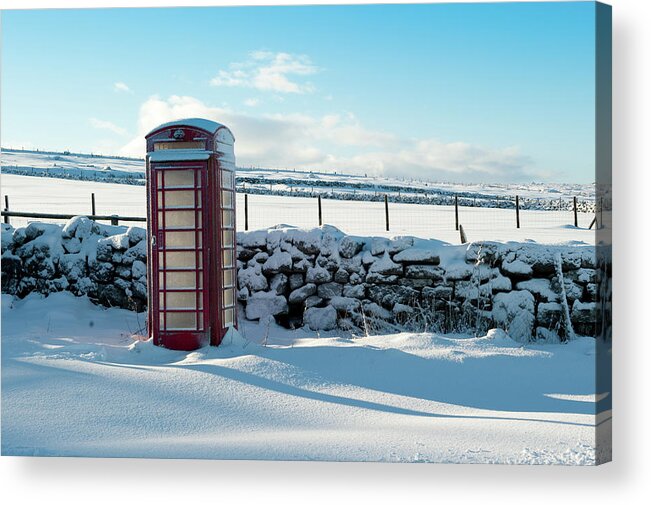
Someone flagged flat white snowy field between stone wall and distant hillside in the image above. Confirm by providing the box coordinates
[1,174,595,244]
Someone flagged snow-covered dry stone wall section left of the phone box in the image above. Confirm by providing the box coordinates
[2,216,147,310]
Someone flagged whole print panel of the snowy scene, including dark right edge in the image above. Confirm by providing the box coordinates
[1,2,613,465]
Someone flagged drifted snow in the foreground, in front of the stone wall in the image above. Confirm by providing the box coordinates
[2,293,610,465]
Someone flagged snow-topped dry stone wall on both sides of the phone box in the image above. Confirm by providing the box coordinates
[2,217,611,342]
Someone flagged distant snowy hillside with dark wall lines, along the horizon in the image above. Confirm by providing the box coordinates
[1,150,595,212]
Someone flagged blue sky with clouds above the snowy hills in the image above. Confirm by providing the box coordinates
[1,2,595,182]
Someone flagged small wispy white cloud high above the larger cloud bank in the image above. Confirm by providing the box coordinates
[210,51,319,93]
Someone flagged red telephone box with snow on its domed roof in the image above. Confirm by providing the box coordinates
[146,118,237,350]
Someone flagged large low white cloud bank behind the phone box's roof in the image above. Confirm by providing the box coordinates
[121,96,547,182]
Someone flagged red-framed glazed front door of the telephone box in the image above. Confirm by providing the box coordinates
[149,162,210,350]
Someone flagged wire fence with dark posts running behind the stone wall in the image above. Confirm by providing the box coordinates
[3,183,603,243]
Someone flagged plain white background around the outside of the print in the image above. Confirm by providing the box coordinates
[0,0,651,505]
